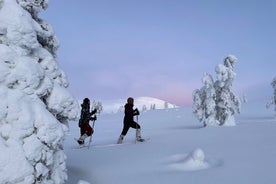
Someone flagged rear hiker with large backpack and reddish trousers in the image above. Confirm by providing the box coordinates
[78,98,97,145]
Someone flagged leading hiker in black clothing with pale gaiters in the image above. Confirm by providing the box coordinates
[117,97,144,144]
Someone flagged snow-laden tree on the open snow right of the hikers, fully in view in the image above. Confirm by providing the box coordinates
[193,55,240,126]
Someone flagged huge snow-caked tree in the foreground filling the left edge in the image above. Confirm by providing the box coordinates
[0,0,79,184]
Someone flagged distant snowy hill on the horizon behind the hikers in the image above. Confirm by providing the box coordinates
[102,97,177,113]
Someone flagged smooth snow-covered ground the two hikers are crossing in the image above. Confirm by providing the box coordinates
[65,104,276,184]
